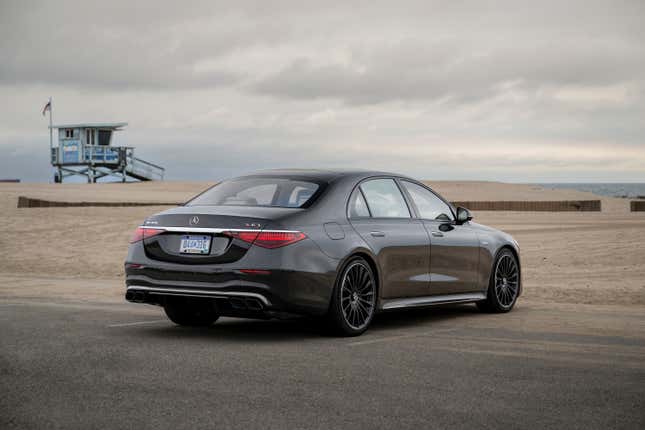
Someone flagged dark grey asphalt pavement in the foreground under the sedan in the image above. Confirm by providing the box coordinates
[0,298,645,429]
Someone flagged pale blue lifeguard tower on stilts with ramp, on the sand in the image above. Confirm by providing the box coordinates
[49,122,165,183]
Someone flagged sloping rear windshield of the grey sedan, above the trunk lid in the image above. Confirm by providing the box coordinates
[186,177,324,208]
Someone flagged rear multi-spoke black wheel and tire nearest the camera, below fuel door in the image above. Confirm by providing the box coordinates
[327,257,377,336]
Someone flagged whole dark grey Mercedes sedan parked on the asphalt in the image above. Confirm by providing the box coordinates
[125,170,522,336]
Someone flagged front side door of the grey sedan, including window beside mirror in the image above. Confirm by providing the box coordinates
[400,180,479,295]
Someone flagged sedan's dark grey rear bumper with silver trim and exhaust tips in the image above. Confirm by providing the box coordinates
[125,228,339,315]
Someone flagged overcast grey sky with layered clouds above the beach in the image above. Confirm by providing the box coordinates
[0,0,645,182]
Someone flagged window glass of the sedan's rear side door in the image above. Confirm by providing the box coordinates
[361,179,410,218]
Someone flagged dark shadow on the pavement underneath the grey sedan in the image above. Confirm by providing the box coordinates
[138,305,481,342]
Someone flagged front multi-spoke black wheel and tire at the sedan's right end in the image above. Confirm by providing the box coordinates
[477,249,520,313]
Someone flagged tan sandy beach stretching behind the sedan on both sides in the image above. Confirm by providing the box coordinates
[0,181,645,306]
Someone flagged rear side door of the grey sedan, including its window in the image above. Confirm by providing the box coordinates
[348,178,430,299]
